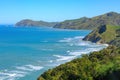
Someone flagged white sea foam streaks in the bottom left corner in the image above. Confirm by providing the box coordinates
[0,64,43,80]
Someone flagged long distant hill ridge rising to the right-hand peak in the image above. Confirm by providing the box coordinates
[54,12,120,29]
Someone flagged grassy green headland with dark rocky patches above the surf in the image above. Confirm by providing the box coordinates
[83,25,120,47]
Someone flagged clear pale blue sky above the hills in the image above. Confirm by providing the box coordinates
[0,0,120,24]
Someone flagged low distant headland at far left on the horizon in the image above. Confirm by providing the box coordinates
[15,19,57,27]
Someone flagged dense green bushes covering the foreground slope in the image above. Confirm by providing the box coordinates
[38,46,120,80]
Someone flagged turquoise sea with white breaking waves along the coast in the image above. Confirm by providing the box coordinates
[0,26,106,80]
